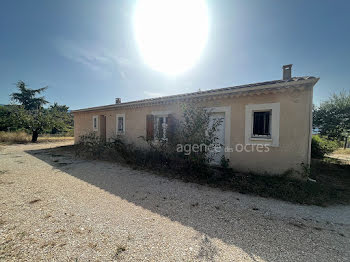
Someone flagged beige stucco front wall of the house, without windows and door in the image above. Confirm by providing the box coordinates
[74,87,312,174]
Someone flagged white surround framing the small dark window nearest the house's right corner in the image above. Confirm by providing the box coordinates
[245,103,280,147]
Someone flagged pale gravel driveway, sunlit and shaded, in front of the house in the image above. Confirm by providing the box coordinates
[0,142,350,261]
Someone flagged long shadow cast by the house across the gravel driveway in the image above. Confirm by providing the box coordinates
[26,147,346,261]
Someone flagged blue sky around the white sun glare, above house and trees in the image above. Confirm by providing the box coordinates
[0,0,350,109]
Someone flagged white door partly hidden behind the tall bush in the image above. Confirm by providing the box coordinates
[209,113,225,164]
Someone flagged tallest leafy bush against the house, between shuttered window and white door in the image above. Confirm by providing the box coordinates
[142,104,221,177]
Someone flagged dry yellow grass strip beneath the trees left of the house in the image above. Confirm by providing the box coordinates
[0,131,73,144]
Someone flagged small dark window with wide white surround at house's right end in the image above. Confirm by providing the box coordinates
[245,103,280,147]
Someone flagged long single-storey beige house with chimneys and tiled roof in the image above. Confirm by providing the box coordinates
[73,65,319,174]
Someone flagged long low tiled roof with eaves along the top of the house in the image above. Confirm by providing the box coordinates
[72,76,319,113]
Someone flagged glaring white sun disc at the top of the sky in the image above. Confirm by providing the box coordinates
[133,0,208,75]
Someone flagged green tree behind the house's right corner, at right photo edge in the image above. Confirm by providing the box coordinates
[313,92,350,146]
